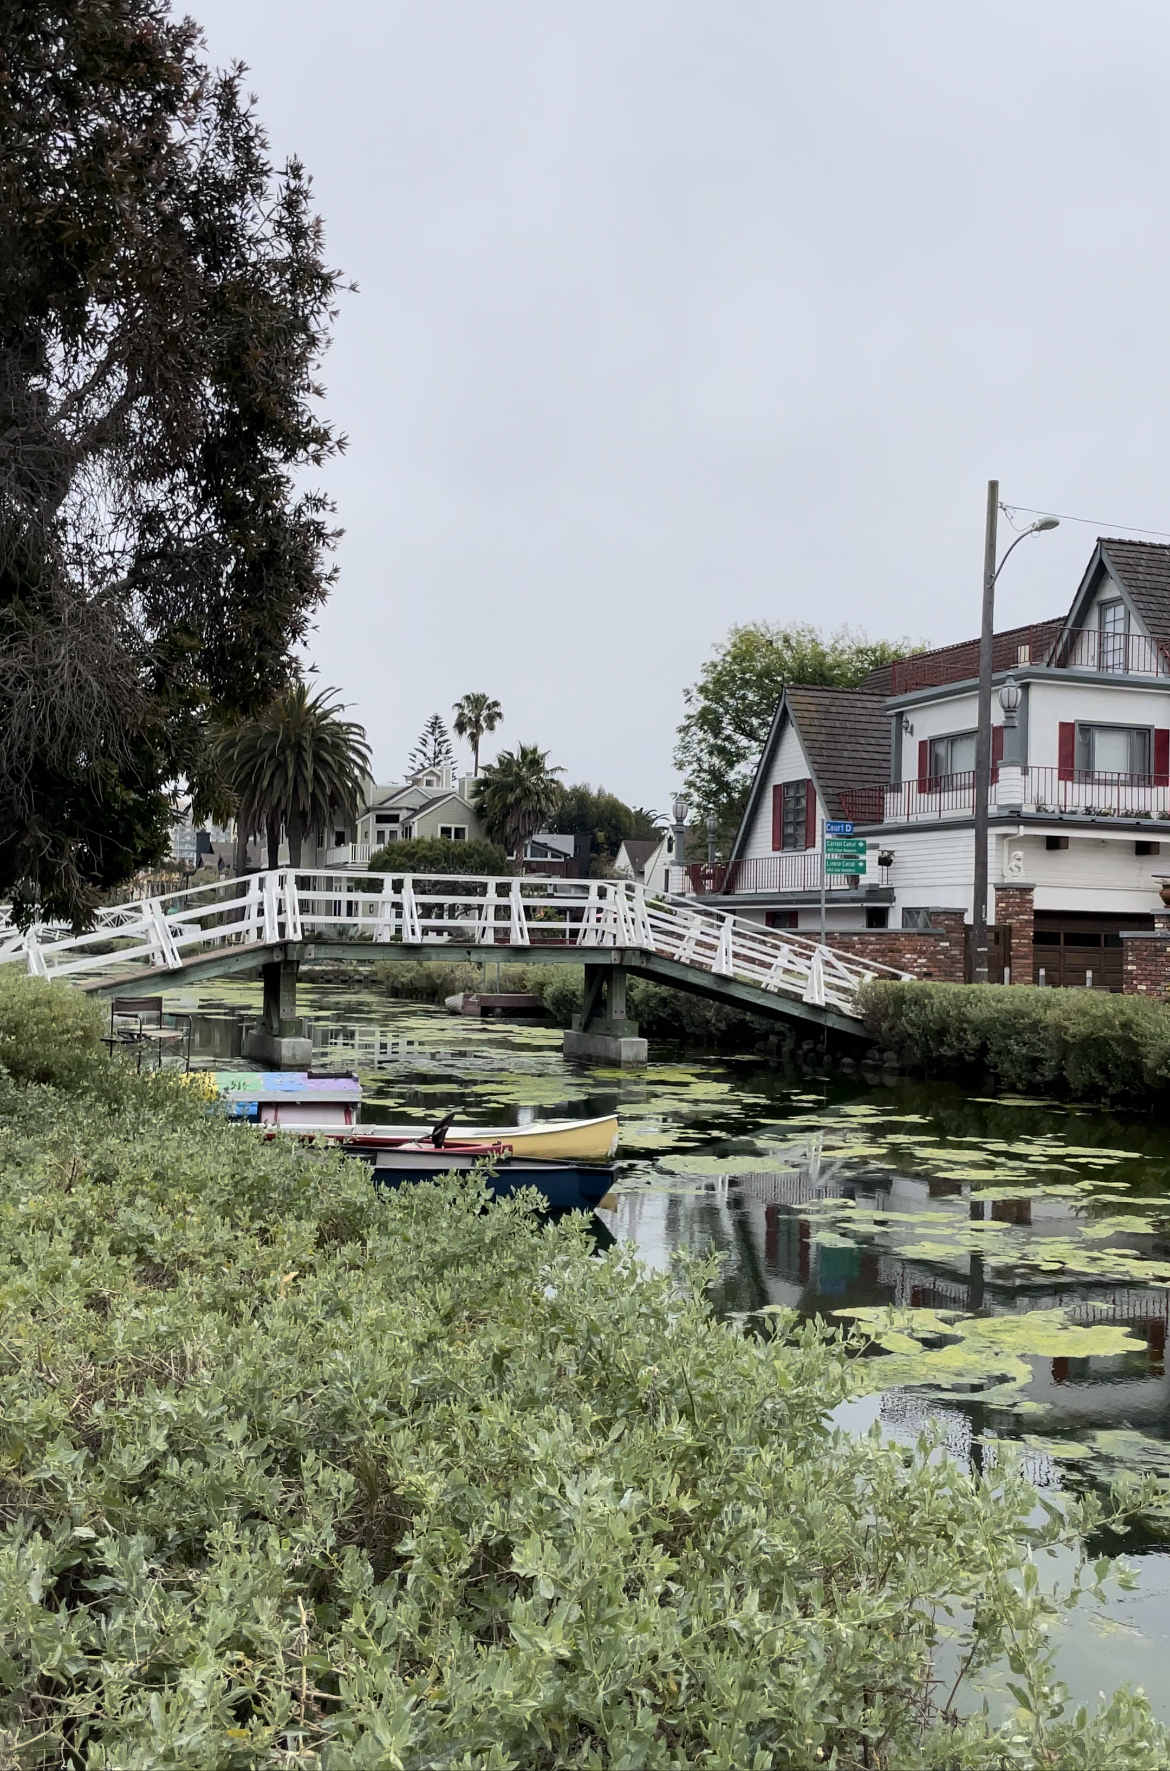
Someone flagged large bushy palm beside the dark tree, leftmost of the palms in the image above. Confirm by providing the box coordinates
[218,682,370,868]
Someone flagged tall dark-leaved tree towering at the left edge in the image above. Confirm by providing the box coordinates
[0,0,340,924]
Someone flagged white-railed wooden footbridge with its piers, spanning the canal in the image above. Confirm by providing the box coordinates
[0,868,904,1034]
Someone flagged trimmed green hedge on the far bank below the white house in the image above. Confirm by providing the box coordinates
[860,983,1170,1103]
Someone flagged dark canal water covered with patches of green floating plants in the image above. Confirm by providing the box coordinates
[176,981,1170,1723]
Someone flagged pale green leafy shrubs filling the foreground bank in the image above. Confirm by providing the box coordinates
[0,1068,1170,1771]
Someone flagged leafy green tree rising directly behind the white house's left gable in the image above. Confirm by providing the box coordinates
[674,622,922,845]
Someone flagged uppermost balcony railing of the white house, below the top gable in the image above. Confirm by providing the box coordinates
[890,622,1170,694]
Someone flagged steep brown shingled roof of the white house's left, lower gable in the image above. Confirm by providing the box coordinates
[731,684,890,861]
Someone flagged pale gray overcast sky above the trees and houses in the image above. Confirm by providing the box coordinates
[191,0,1170,808]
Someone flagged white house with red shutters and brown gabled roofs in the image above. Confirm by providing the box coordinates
[687,538,1170,988]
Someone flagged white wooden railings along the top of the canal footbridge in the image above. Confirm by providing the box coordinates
[0,868,904,1015]
